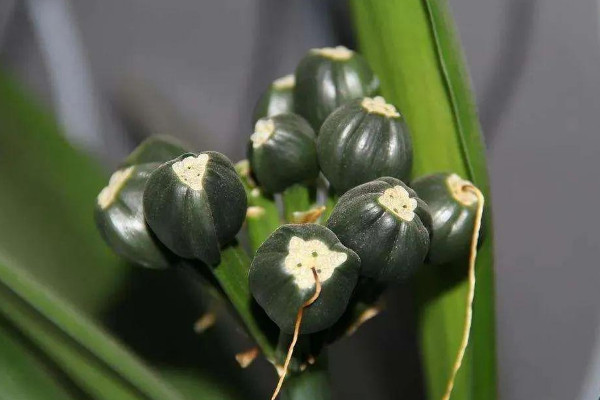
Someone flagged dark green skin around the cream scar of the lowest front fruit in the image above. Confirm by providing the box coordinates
[249,224,360,334]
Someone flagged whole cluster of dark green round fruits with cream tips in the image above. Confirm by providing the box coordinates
[95,47,486,380]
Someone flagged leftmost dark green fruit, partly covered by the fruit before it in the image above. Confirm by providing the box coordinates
[94,163,175,269]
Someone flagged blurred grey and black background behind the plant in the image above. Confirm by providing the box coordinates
[0,0,600,400]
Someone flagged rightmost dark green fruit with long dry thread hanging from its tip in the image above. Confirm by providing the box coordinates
[412,173,482,264]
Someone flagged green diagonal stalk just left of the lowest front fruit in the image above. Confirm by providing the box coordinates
[213,245,278,362]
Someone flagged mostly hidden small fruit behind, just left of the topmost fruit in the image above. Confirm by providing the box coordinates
[253,75,296,123]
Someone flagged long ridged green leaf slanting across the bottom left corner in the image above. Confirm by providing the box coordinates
[0,255,181,400]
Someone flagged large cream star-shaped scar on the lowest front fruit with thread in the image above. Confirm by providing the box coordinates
[283,236,348,289]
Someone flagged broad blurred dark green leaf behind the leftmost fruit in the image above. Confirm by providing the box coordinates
[0,73,129,313]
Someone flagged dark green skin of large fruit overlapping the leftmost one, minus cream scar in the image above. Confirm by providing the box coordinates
[144,151,247,265]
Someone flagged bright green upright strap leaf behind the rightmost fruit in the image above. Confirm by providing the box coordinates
[351,0,496,399]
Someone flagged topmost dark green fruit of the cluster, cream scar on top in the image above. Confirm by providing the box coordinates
[294,46,379,133]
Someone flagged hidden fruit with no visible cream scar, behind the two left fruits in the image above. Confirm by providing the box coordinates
[121,135,188,167]
